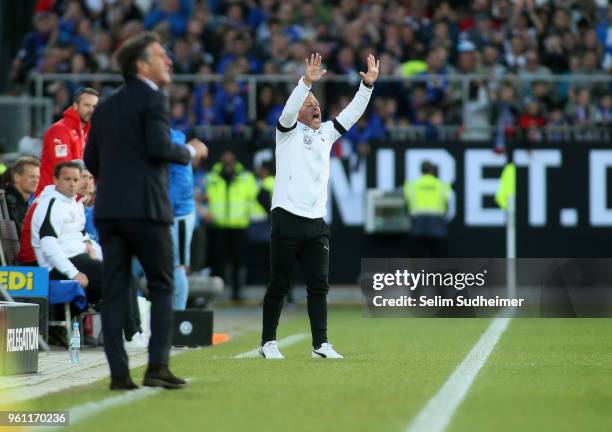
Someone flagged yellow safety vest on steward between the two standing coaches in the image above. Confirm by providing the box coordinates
[206,162,257,228]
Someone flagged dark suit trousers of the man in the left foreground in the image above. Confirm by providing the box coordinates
[96,219,174,376]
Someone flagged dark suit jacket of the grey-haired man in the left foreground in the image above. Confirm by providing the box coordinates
[85,78,190,222]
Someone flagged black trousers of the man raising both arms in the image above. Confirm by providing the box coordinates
[261,208,330,347]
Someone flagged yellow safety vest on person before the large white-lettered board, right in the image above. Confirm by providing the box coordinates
[404,174,450,216]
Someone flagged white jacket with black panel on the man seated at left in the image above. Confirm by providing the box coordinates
[32,188,89,279]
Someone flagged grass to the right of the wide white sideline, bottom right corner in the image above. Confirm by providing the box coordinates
[448,319,612,432]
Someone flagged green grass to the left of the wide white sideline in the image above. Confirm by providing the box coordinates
[28,309,489,432]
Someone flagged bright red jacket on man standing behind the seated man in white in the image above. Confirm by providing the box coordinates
[36,107,90,195]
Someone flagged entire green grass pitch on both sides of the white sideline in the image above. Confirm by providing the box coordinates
[16,308,612,432]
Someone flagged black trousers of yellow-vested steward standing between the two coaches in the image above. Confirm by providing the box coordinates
[209,228,247,300]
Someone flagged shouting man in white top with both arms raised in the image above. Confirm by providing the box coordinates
[259,53,379,359]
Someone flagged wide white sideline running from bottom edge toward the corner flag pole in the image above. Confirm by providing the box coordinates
[406,318,510,432]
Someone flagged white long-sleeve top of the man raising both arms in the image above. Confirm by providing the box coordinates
[272,78,372,219]
